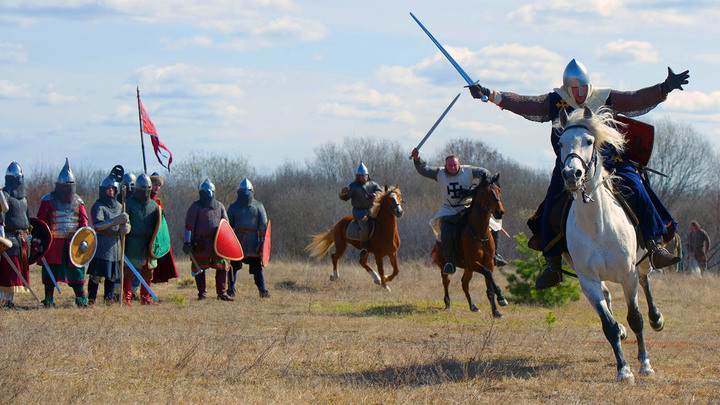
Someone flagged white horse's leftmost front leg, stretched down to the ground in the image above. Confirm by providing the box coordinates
[579,277,635,384]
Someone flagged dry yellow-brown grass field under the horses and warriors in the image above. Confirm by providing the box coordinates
[0,258,720,404]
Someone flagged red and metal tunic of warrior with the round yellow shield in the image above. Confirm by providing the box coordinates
[37,191,88,284]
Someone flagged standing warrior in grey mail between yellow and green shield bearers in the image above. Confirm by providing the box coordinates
[88,176,130,305]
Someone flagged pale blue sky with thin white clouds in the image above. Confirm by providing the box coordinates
[0,0,720,178]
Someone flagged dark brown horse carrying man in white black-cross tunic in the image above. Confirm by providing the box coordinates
[434,174,507,318]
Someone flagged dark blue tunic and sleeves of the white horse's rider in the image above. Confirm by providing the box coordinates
[499,84,677,257]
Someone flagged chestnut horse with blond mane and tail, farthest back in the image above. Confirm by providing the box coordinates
[305,185,403,291]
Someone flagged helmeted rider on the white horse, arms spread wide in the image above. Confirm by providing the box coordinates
[470,59,690,289]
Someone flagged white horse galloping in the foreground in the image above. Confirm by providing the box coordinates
[559,107,665,384]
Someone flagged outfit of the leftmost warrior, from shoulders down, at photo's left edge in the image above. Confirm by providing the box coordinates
[0,187,30,293]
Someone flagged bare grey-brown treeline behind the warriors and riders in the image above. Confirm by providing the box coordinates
[16,121,720,264]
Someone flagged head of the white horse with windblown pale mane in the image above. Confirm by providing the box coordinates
[558,107,625,193]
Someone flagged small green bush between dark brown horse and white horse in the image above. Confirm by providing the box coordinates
[500,232,580,307]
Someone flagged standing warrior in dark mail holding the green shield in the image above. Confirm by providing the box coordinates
[123,174,160,307]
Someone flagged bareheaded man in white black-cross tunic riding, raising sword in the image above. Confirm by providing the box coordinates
[412,148,490,274]
